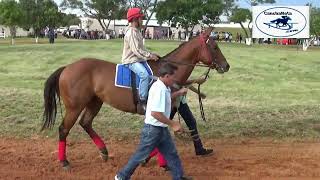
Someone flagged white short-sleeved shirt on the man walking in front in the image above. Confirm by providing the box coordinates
[144,79,171,127]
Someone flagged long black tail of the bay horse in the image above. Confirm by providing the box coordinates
[41,67,65,131]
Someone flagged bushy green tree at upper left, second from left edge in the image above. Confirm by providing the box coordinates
[19,0,61,43]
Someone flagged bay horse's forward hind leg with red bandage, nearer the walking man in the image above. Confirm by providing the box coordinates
[79,97,108,161]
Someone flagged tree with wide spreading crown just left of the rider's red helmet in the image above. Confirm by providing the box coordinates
[60,0,126,30]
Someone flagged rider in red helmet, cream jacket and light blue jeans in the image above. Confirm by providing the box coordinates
[122,8,159,112]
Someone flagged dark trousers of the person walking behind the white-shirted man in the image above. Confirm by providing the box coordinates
[170,103,203,152]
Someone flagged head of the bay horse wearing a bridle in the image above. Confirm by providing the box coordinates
[198,28,230,73]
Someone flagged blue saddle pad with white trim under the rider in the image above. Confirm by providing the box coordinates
[114,62,153,89]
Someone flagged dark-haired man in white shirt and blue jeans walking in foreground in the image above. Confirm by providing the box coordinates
[115,64,191,180]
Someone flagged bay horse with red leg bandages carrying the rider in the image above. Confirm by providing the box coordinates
[41,29,230,169]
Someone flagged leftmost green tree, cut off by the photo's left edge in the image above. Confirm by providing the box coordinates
[0,0,22,45]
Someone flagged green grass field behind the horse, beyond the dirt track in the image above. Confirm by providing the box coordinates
[0,39,320,139]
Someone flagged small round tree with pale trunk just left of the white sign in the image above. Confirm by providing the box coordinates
[230,8,252,38]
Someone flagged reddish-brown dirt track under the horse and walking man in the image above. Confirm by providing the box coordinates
[0,138,320,180]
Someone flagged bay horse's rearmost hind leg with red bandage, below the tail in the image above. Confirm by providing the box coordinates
[58,108,81,170]
